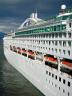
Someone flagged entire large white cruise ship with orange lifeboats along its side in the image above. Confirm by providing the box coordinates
[3,4,72,96]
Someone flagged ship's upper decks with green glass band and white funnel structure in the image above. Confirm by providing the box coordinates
[10,4,72,36]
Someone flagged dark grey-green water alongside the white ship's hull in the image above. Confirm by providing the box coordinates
[0,40,44,96]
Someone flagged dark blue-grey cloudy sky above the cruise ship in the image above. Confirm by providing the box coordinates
[0,0,72,32]
